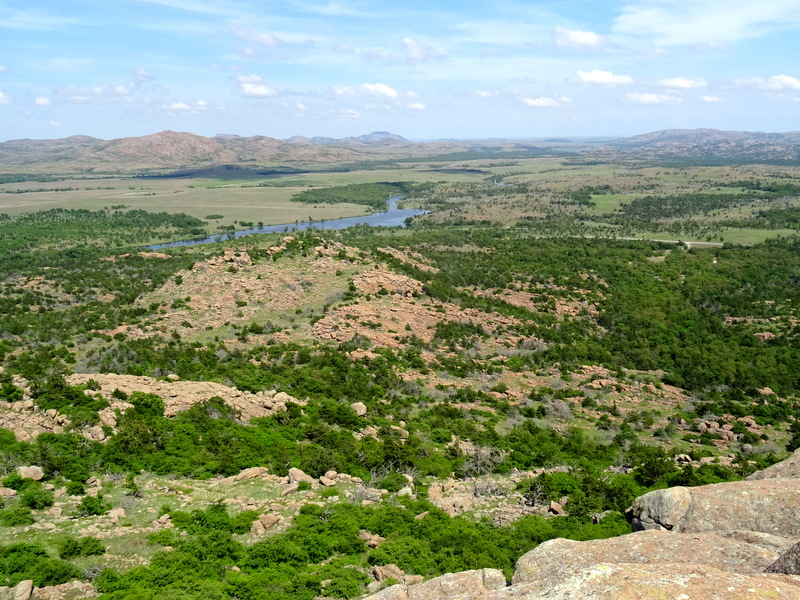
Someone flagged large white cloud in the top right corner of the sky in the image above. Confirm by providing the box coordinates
[613,0,800,46]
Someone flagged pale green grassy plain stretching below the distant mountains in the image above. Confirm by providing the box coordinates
[0,156,800,244]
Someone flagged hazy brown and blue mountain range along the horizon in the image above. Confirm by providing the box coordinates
[0,129,800,172]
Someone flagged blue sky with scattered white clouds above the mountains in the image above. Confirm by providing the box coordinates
[0,0,800,140]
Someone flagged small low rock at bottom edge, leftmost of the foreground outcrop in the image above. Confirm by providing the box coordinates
[365,569,506,600]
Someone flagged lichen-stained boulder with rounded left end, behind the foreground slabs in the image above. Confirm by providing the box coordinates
[630,479,800,538]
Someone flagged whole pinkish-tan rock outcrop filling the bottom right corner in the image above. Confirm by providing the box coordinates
[368,466,800,600]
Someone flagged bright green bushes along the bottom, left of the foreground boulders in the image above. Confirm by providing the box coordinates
[95,501,628,600]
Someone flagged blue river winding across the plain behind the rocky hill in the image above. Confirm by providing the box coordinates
[148,194,428,250]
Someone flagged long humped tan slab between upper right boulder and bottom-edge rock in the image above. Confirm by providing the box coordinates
[512,531,780,583]
